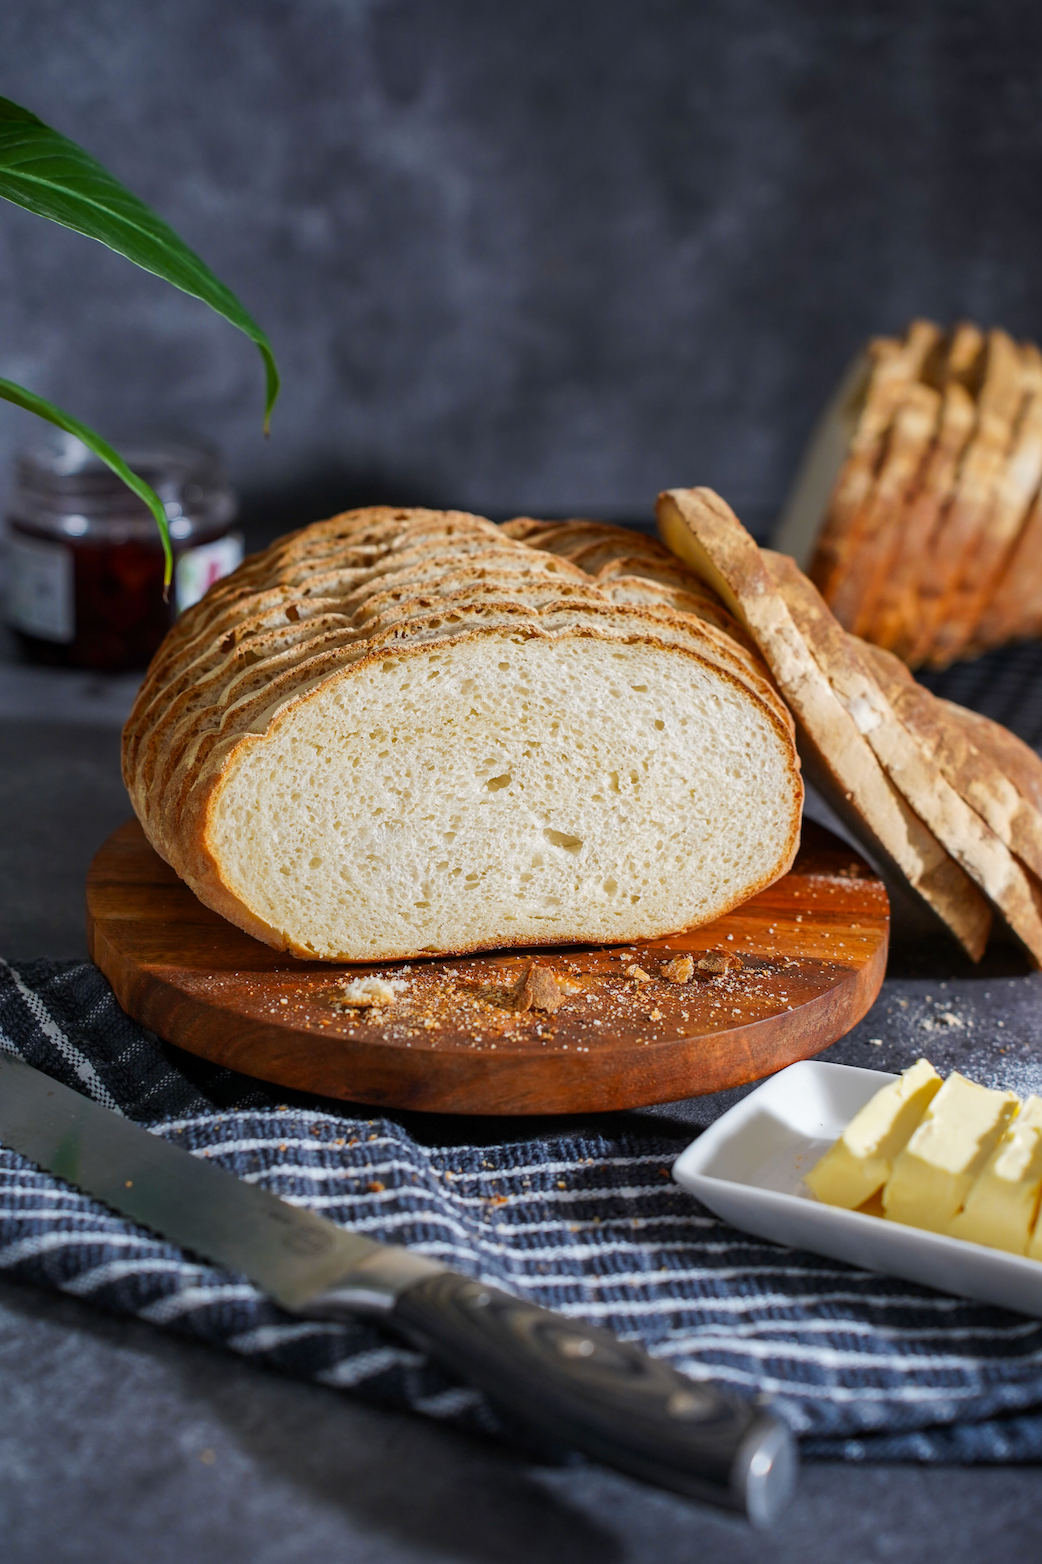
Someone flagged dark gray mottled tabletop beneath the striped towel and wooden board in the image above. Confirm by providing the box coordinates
[0,665,1042,1564]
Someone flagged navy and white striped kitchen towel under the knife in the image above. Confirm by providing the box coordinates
[0,962,1042,1462]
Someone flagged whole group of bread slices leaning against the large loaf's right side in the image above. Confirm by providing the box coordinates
[659,490,1042,963]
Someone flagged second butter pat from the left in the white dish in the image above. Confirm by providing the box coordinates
[882,1070,1019,1232]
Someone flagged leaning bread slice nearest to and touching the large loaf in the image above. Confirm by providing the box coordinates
[659,488,992,960]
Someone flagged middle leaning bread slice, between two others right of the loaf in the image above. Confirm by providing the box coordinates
[765,552,1042,965]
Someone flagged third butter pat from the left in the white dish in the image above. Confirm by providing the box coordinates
[948,1096,1042,1254]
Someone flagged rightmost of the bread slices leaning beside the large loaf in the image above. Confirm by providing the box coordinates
[857,641,1042,876]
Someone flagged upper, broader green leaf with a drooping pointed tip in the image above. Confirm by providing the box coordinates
[0,97,278,431]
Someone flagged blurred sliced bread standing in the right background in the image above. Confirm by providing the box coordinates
[778,321,1042,668]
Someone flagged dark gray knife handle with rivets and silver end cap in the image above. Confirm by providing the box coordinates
[390,1272,796,1525]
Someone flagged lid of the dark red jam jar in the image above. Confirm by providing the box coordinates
[11,430,236,527]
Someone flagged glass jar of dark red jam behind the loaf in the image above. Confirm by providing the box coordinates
[5,432,243,673]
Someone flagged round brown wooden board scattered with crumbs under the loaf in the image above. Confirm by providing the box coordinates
[88,821,889,1114]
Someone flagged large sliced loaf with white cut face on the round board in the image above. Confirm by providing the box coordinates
[124,508,803,962]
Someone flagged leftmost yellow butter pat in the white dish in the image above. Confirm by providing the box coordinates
[804,1059,940,1211]
